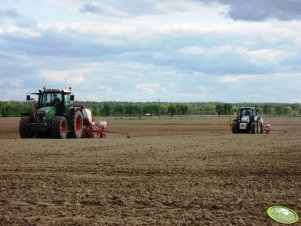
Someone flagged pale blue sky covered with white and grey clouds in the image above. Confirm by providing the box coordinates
[0,0,301,102]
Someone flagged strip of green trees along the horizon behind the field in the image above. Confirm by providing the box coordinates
[0,101,301,117]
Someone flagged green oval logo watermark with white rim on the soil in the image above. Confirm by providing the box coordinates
[267,206,298,224]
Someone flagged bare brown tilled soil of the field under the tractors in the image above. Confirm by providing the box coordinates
[0,117,301,226]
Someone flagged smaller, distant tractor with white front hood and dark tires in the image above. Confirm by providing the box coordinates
[232,107,264,133]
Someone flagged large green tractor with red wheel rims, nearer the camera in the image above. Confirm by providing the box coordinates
[19,87,83,139]
